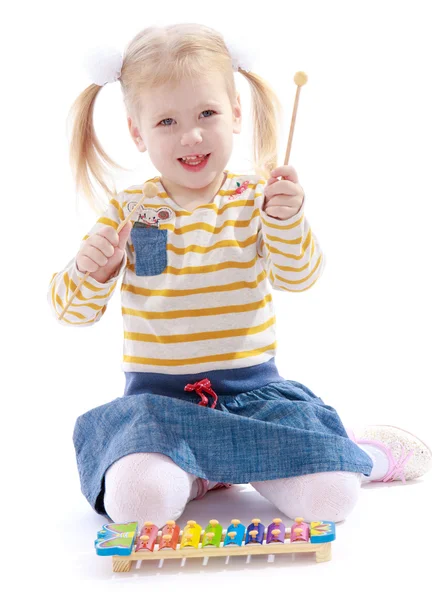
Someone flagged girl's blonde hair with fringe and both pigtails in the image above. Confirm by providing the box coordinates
[69,23,282,212]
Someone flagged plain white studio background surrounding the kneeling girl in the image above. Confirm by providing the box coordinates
[1,0,432,598]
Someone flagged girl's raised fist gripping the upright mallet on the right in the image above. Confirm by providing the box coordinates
[263,165,304,219]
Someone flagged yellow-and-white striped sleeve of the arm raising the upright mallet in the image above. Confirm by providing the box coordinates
[257,188,325,292]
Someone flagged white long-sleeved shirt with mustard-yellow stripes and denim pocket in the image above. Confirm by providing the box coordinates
[48,171,324,374]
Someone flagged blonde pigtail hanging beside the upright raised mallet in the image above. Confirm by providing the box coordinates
[239,67,282,179]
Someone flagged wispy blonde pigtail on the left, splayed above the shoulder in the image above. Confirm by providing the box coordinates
[68,84,125,214]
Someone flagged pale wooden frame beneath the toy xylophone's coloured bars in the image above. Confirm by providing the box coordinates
[112,528,331,573]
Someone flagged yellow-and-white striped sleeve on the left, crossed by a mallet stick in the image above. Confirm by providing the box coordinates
[47,194,127,327]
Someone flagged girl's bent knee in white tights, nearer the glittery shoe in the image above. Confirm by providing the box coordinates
[250,471,361,523]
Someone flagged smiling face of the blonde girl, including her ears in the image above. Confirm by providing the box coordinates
[128,73,241,189]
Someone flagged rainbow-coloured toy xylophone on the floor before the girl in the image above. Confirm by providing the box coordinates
[95,517,336,572]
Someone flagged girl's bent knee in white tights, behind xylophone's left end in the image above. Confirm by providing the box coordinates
[104,452,198,529]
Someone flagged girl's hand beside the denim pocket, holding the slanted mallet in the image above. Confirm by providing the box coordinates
[75,221,132,283]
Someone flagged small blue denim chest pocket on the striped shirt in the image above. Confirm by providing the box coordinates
[131,225,168,276]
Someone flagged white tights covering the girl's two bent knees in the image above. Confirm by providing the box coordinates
[104,452,363,528]
